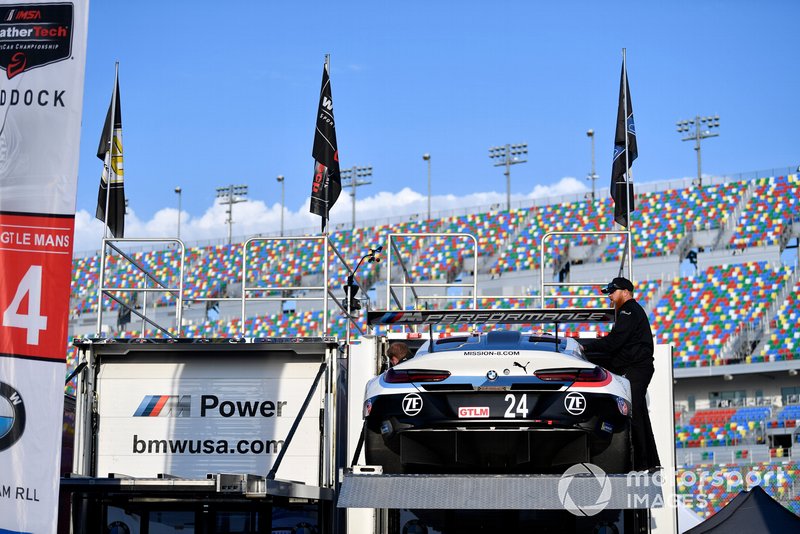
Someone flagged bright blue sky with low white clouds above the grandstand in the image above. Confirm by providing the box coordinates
[76,0,800,252]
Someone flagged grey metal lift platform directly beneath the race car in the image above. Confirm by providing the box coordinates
[337,473,664,510]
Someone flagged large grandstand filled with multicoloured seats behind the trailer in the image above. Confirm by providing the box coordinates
[67,174,800,515]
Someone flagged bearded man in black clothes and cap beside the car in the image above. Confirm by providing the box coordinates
[584,277,660,471]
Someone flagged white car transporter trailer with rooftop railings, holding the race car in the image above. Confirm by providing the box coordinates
[61,232,676,534]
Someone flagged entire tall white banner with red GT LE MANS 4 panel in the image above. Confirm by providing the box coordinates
[0,0,88,534]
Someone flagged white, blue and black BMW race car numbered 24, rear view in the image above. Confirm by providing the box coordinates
[363,330,632,474]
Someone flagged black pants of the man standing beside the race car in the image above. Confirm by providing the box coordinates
[625,365,661,471]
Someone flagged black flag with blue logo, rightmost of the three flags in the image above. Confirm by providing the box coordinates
[611,61,639,228]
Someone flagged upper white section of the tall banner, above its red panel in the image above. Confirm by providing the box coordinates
[0,1,86,215]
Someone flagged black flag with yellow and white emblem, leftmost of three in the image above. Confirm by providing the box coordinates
[95,70,125,237]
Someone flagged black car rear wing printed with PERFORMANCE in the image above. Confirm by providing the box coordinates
[367,308,615,326]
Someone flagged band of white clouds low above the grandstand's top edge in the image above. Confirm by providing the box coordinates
[75,177,587,255]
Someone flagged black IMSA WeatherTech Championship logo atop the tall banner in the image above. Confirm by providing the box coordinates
[0,3,73,79]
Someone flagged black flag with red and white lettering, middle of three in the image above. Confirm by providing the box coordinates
[311,63,342,232]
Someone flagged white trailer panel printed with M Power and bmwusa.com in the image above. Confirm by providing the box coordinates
[97,356,323,486]
